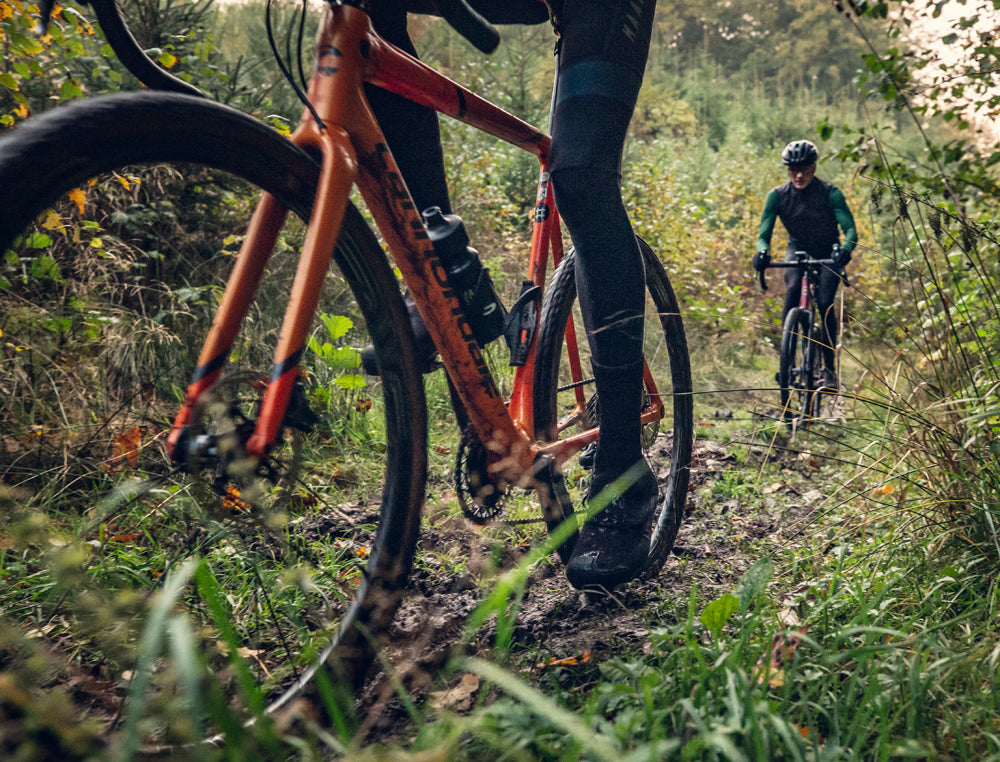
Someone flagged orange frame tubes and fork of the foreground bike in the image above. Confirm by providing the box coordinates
[171,1,572,482]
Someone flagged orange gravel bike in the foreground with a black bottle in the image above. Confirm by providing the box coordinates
[0,0,693,732]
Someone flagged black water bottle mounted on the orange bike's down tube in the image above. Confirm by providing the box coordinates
[423,206,507,346]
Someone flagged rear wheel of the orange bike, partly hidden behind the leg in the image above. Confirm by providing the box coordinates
[534,239,694,576]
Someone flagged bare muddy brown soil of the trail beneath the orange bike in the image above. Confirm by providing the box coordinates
[352,411,821,742]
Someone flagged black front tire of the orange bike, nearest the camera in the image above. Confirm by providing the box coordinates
[0,93,427,725]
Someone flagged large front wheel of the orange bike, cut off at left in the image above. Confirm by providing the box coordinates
[0,93,427,742]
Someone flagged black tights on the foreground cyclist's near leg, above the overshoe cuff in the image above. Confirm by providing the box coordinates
[551,0,656,367]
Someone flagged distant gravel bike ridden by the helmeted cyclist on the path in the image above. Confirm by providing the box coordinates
[759,251,834,422]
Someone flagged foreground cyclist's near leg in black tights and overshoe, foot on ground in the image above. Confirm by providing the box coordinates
[552,0,656,586]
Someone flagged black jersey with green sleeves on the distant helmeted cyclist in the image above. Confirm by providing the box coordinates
[757,177,858,259]
